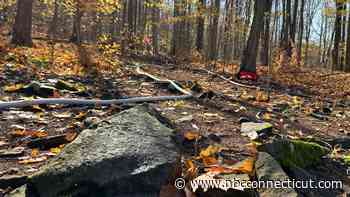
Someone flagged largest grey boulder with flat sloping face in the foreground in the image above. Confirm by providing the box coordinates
[28,105,178,197]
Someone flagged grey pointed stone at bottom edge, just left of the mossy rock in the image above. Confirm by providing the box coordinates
[255,152,298,197]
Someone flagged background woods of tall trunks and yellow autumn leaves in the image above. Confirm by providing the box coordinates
[0,0,350,72]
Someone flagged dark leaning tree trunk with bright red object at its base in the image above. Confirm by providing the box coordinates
[240,0,269,73]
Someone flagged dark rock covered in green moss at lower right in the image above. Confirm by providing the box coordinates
[260,139,329,168]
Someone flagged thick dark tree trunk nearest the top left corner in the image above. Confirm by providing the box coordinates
[11,0,33,47]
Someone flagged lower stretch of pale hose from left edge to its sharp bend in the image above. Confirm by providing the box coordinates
[0,95,193,110]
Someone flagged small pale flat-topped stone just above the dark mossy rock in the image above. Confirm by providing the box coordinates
[241,122,272,140]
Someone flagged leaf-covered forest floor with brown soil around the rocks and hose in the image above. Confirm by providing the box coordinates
[0,38,350,195]
